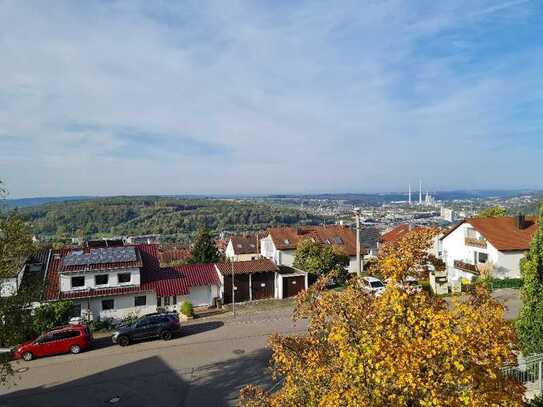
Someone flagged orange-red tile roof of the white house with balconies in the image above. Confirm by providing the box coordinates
[442,216,539,251]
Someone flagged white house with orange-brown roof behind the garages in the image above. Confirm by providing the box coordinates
[260,225,365,272]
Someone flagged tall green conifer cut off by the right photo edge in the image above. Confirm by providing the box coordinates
[516,205,543,354]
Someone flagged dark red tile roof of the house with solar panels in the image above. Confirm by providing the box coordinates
[45,244,220,301]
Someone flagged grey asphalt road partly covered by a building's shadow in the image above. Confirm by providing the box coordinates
[0,309,306,407]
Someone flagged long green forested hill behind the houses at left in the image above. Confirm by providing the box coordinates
[19,197,323,241]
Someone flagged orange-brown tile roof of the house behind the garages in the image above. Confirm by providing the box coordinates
[268,225,356,256]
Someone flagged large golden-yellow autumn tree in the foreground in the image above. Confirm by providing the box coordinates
[240,231,524,407]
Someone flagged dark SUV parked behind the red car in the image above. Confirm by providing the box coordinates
[111,313,181,346]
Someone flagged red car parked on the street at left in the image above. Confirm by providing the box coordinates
[15,324,92,361]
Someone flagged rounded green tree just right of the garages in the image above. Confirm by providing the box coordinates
[294,239,349,280]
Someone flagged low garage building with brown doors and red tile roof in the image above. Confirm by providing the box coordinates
[215,259,308,304]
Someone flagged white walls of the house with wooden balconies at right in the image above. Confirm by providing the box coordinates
[441,222,524,280]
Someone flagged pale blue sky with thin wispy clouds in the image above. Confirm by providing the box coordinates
[0,0,543,197]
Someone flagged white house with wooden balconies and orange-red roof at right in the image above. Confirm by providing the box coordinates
[441,215,538,280]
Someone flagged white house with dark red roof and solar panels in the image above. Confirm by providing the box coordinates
[44,244,220,320]
